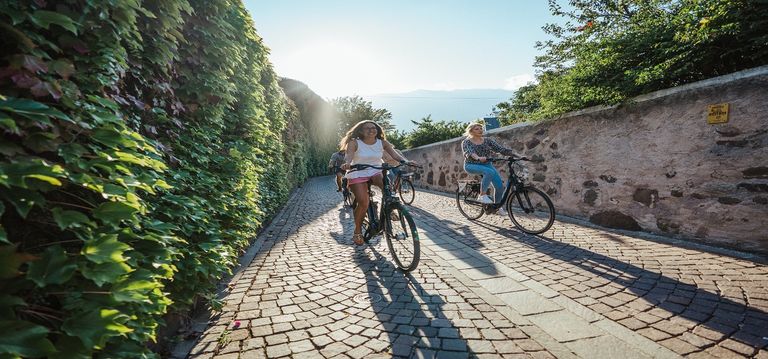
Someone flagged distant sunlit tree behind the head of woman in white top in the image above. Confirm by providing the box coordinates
[331,96,395,139]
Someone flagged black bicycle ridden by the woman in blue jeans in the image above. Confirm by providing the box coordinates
[456,157,555,234]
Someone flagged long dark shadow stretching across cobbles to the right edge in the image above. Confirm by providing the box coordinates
[438,211,768,350]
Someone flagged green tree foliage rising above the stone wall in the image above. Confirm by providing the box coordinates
[499,0,768,120]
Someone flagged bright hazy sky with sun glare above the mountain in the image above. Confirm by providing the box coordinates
[245,0,559,98]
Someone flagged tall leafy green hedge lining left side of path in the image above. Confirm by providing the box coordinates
[0,0,314,358]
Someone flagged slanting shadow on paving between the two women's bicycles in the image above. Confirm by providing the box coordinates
[408,207,499,275]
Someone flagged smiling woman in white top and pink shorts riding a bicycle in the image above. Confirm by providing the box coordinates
[340,121,410,245]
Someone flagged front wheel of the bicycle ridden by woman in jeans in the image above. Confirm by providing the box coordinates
[507,187,555,234]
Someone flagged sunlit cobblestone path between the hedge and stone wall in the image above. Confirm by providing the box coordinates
[180,177,768,358]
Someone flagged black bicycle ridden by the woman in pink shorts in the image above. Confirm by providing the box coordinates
[351,163,421,272]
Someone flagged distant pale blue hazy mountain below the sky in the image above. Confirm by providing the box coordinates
[363,89,514,131]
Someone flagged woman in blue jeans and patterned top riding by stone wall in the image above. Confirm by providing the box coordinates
[461,122,515,216]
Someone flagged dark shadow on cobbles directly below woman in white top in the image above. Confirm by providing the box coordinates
[354,243,468,357]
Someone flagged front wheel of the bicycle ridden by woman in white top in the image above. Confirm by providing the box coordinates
[384,204,421,272]
